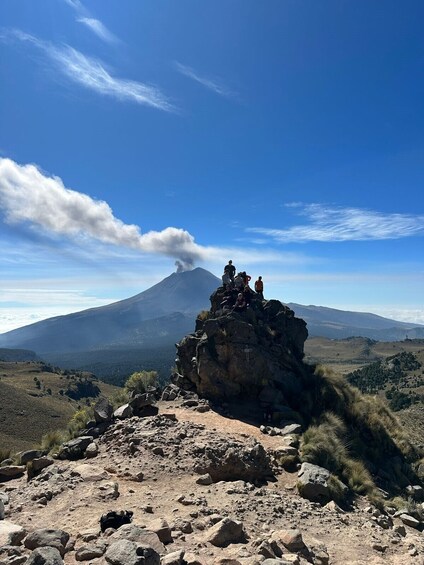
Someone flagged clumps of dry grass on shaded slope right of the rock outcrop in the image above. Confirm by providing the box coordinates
[298,367,419,501]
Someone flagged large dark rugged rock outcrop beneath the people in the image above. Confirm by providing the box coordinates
[173,287,308,411]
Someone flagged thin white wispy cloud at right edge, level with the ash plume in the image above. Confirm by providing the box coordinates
[247,203,424,243]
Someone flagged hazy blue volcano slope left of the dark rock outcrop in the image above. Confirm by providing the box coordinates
[0,268,220,353]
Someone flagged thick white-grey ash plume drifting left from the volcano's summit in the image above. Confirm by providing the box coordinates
[0,158,206,271]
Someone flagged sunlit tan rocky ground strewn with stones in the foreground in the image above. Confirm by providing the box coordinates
[0,400,424,565]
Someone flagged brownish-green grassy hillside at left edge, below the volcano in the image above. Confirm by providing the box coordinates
[0,361,119,451]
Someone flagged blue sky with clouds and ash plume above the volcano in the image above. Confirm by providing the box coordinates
[0,0,424,332]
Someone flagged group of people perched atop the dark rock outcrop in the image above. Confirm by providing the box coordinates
[221,259,264,312]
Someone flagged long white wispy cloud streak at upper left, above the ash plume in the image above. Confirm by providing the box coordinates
[0,30,175,112]
